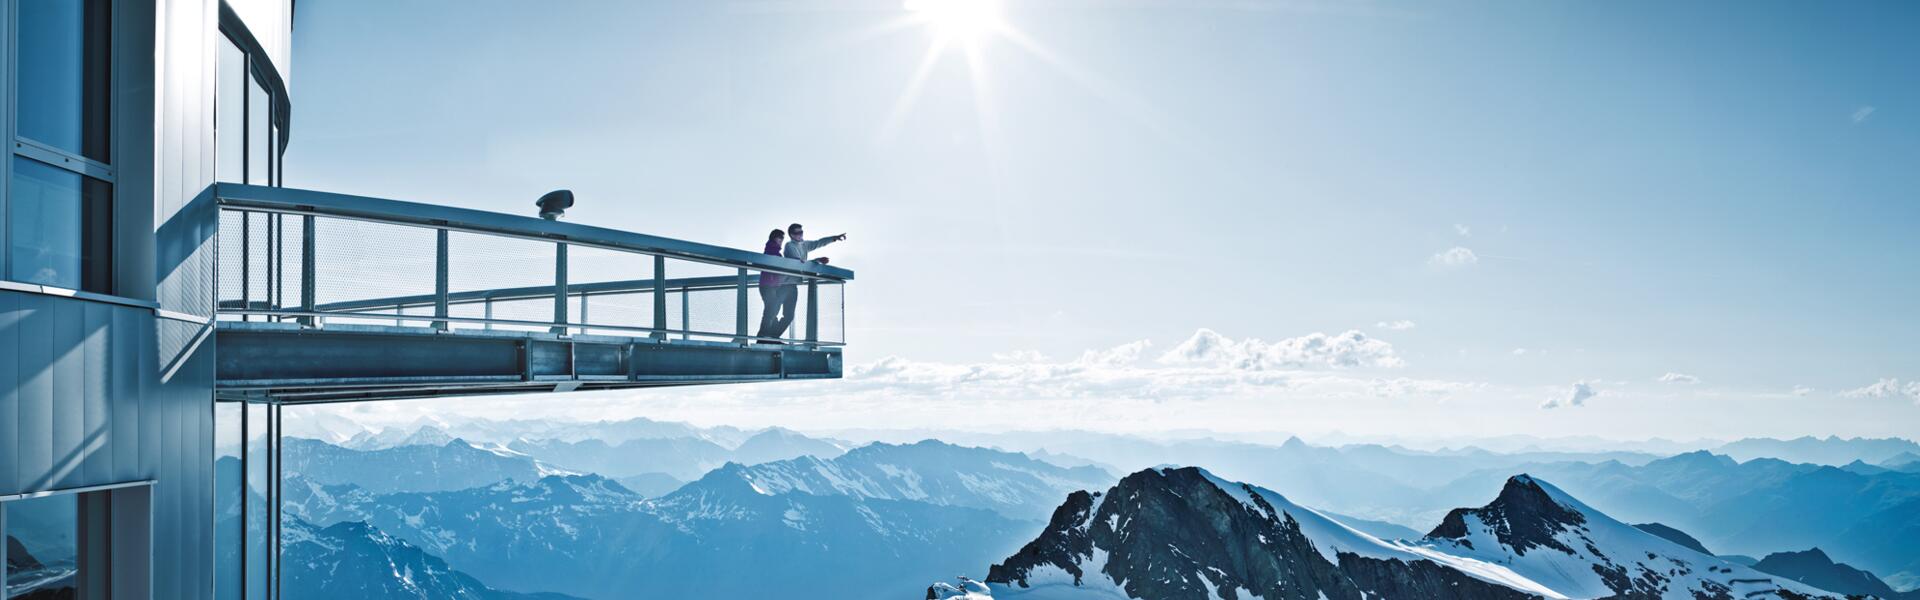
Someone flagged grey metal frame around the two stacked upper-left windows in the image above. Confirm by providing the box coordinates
[0,0,119,296]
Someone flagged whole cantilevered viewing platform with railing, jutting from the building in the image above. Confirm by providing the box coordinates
[200,183,852,404]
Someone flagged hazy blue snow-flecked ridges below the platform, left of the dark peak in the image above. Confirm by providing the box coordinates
[282,442,1082,600]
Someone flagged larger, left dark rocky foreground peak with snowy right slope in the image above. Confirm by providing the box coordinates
[987,467,1551,600]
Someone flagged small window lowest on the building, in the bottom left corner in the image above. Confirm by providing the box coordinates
[0,494,81,600]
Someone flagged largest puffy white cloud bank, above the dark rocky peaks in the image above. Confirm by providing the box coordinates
[1160,329,1405,371]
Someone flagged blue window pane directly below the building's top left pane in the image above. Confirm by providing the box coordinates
[8,156,113,292]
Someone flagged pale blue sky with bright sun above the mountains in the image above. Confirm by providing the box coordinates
[286,0,1920,438]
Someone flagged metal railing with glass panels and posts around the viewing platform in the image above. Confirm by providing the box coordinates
[215,183,852,346]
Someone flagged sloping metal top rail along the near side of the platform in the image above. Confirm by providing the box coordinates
[213,183,852,281]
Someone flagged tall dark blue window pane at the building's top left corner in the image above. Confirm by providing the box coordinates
[13,0,108,162]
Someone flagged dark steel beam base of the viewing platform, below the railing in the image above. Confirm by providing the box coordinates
[215,321,841,404]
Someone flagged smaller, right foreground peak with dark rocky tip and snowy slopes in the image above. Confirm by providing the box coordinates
[1421,475,1832,600]
